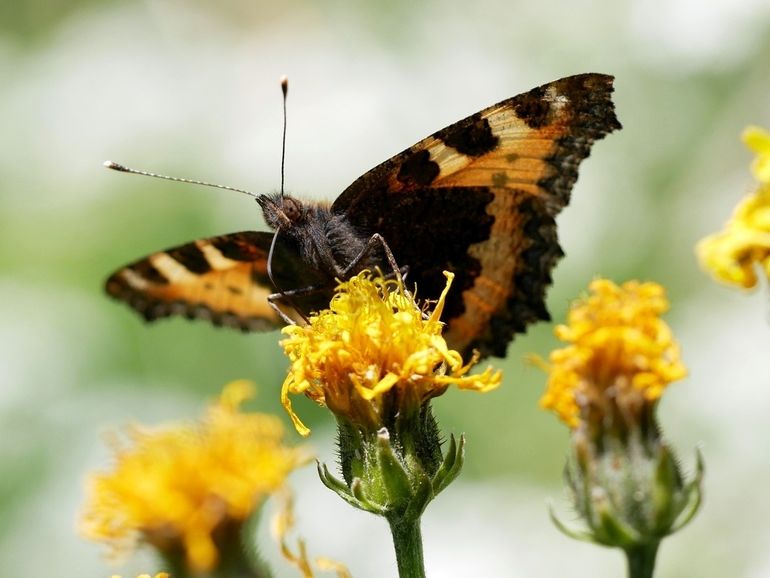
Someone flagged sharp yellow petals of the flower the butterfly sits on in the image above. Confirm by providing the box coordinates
[281,271,501,435]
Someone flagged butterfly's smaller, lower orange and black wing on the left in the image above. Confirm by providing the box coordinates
[105,231,293,331]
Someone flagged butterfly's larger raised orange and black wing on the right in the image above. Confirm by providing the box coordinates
[332,74,620,356]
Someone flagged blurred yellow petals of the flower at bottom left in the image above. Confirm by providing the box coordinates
[80,381,308,572]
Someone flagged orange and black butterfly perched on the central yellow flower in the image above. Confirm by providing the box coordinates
[106,74,621,357]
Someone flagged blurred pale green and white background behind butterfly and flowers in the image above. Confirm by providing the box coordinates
[0,0,770,578]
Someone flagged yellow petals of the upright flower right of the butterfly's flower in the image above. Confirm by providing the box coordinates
[540,279,687,428]
